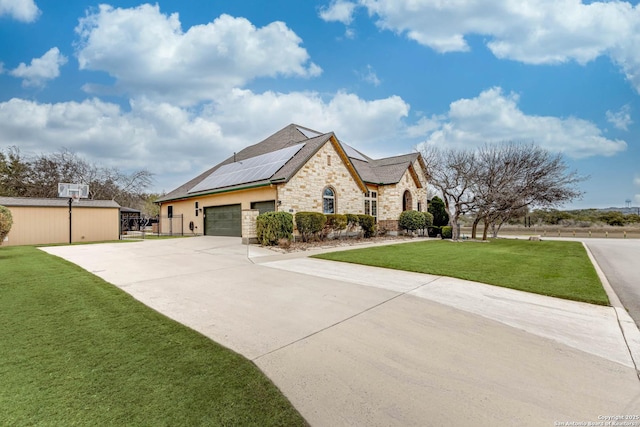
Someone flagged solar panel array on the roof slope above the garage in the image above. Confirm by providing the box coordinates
[188,143,304,193]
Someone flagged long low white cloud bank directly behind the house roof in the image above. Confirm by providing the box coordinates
[0,89,409,190]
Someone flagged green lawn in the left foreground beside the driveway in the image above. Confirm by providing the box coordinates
[0,247,306,426]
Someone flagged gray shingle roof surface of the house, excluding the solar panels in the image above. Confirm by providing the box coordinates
[158,124,419,202]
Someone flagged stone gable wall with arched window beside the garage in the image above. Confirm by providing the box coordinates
[278,141,364,215]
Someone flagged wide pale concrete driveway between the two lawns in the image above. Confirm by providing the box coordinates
[45,237,640,426]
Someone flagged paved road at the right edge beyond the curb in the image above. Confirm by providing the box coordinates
[583,239,640,327]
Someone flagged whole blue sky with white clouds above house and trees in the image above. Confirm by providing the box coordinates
[0,0,640,209]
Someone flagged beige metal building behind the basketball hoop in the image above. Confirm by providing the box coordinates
[0,197,120,246]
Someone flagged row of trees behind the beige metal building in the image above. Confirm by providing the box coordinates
[0,146,158,216]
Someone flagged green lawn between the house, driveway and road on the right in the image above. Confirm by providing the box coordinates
[316,239,609,305]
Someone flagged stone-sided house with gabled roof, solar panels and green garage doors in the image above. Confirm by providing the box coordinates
[158,124,427,238]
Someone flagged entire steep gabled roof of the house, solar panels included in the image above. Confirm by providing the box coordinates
[158,124,419,202]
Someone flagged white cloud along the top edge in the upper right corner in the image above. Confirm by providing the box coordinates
[348,0,640,92]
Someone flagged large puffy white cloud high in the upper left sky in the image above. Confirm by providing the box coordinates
[76,4,321,105]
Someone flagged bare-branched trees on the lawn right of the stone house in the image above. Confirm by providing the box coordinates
[422,142,584,240]
